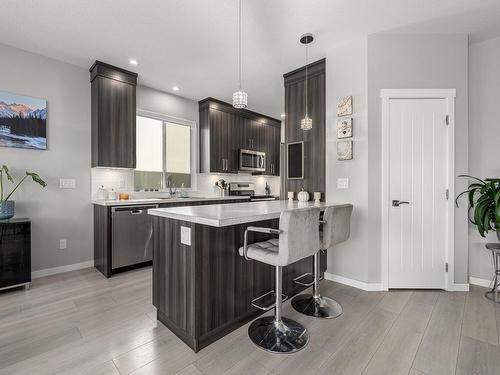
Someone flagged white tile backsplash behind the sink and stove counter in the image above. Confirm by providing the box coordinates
[91,168,280,199]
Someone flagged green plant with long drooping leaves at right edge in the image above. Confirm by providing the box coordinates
[455,175,500,241]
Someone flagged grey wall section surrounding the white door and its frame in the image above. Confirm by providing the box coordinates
[367,35,468,283]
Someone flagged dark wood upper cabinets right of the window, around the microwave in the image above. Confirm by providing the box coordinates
[199,98,281,176]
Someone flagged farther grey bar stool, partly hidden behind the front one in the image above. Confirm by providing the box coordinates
[292,204,353,319]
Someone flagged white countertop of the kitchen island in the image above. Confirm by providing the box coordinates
[148,200,352,227]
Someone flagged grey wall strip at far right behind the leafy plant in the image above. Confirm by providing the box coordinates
[469,38,500,280]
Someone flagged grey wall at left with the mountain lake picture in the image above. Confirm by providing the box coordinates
[0,45,93,270]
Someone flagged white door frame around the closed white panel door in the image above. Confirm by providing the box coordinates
[380,89,456,290]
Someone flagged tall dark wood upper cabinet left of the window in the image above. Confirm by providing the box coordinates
[90,61,137,168]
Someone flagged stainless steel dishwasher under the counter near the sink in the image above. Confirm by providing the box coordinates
[111,204,158,269]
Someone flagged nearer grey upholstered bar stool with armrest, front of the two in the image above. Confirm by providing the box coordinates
[239,207,320,353]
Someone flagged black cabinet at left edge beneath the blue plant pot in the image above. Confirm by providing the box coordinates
[0,219,31,289]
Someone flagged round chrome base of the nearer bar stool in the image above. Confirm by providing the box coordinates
[248,316,309,354]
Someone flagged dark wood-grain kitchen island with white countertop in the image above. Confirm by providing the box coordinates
[148,200,350,352]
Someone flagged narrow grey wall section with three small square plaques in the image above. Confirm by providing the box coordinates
[326,38,373,282]
